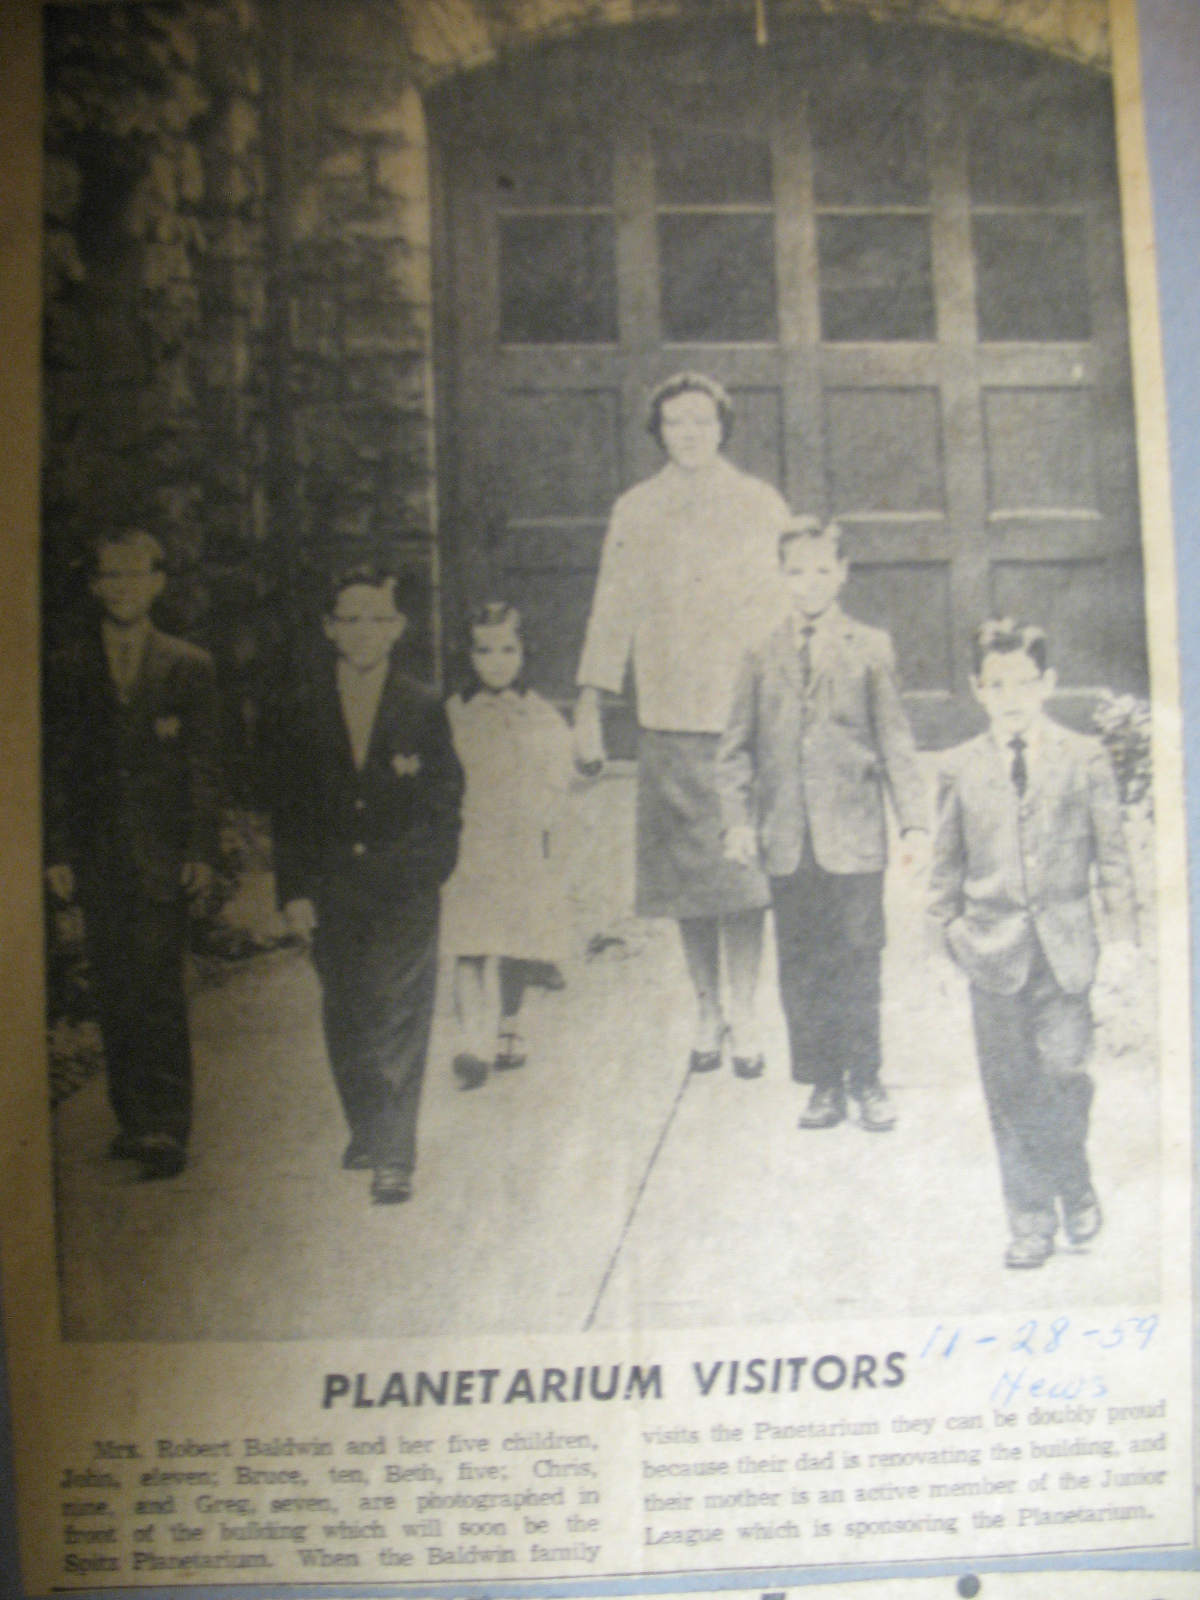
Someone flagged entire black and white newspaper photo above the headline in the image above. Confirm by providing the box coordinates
[42,0,1162,1344]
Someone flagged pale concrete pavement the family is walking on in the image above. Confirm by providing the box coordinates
[56,776,1158,1341]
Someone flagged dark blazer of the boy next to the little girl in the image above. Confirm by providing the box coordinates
[272,636,464,907]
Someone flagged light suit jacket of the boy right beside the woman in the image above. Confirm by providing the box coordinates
[717,610,928,877]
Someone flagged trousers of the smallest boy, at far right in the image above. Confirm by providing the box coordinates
[971,944,1093,1235]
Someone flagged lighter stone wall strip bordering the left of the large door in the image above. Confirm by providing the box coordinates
[280,0,437,674]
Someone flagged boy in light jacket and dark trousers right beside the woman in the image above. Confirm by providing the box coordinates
[717,517,926,1133]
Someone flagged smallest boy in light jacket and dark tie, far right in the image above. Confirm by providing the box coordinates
[930,619,1136,1267]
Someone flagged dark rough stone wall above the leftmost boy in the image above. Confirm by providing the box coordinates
[43,0,275,787]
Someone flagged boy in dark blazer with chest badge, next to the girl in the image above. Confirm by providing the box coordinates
[274,566,462,1205]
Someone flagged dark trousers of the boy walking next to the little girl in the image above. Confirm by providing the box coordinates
[312,878,438,1173]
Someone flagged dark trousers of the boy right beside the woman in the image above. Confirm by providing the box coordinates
[771,835,883,1094]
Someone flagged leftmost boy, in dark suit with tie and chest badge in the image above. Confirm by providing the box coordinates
[45,530,219,1178]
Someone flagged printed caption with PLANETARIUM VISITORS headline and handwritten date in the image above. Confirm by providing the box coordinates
[59,1317,1187,1586]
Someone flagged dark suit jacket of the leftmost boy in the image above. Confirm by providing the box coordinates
[45,627,221,902]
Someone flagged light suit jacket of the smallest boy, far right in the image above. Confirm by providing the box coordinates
[930,718,1138,994]
